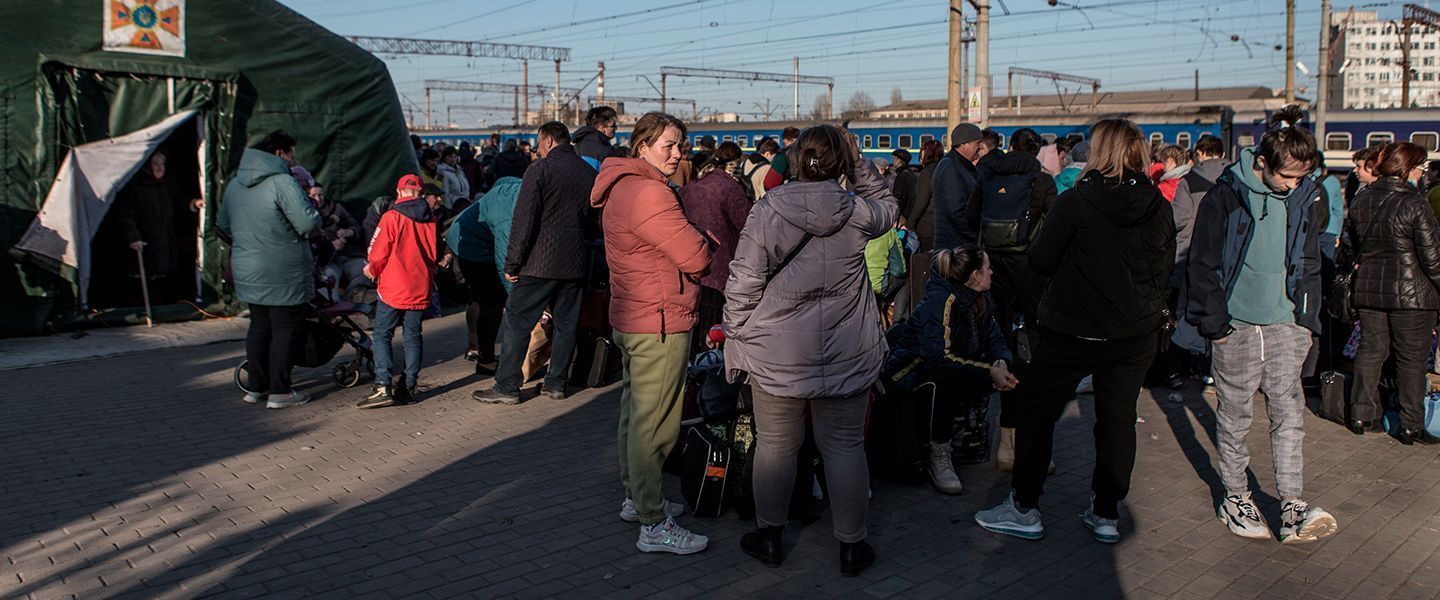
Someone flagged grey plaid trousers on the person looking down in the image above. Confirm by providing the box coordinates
[1212,322,1312,498]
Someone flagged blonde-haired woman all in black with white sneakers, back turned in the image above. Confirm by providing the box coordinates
[975,119,1175,544]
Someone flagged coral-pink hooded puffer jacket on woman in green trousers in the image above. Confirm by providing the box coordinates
[590,158,710,334]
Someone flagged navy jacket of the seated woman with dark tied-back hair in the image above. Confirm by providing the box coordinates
[884,271,1012,380]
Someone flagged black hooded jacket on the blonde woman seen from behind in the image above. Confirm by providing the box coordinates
[1028,171,1175,340]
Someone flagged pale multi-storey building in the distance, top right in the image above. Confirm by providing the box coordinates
[1329,10,1440,108]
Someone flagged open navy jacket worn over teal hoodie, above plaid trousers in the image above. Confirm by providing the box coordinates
[1182,168,1322,340]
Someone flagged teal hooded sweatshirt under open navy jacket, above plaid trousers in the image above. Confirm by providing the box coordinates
[1228,148,1295,325]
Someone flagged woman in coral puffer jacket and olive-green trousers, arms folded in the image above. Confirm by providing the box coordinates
[590,112,710,554]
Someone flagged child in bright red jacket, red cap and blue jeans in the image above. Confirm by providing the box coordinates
[356,176,445,409]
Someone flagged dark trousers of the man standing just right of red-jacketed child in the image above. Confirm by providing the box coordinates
[495,276,585,394]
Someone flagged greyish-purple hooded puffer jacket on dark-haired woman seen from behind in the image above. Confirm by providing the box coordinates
[724,161,900,399]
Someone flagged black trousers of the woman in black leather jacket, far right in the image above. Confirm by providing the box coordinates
[1351,308,1436,430]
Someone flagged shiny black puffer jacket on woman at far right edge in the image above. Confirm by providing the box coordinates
[1341,177,1440,311]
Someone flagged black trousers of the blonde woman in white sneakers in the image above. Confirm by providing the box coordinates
[1009,327,1159,519]
